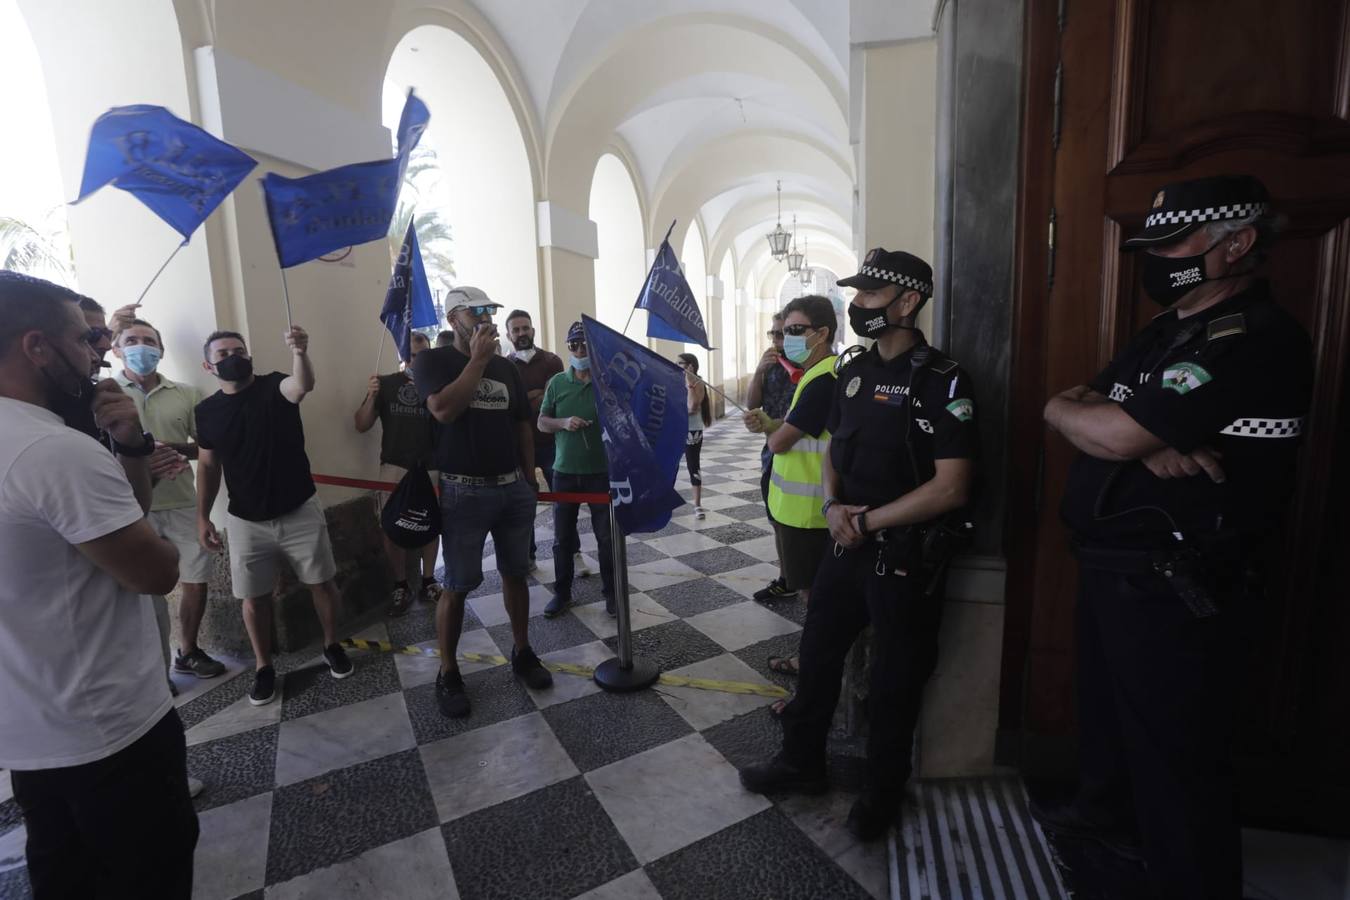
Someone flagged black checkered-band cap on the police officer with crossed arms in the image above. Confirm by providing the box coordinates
[1121,175,1270,250]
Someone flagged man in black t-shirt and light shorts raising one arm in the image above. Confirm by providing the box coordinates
[196,325,352,706]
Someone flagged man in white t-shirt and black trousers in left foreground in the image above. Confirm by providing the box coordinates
[0,271,197,900]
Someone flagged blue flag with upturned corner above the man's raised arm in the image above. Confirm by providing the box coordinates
[262,90,431,269]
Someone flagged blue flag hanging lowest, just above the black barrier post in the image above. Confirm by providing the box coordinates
[582,316,689,534]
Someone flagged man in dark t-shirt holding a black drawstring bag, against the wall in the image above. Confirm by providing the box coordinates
[355,332,440,617]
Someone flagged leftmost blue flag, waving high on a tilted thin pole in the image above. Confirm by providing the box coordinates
[74,104,258,243]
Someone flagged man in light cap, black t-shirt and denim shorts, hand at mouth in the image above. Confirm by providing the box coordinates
[413,287,554,718]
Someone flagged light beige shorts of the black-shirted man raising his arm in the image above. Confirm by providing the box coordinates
[225,497,338,599]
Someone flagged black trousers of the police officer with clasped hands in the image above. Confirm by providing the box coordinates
[782,541,942,793]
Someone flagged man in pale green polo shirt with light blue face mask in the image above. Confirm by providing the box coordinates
[112,318,225,679]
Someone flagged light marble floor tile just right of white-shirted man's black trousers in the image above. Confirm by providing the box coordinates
[192,793,271,900]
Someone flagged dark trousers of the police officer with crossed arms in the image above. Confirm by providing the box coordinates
[1075,567,1242,900]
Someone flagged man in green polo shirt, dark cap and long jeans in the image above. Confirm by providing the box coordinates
[539,322,614,618]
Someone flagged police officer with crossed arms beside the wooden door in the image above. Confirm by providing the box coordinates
[1033,175,1312,900]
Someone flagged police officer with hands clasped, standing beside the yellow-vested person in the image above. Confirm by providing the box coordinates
[741,248,976,841]
